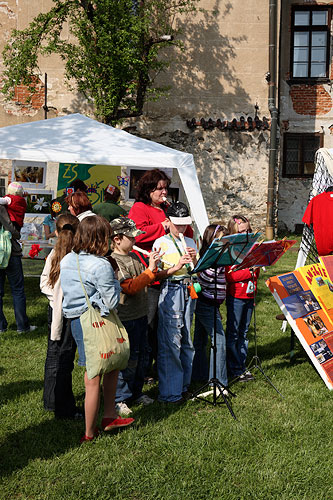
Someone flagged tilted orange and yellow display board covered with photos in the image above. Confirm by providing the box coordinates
[266,255,333,390]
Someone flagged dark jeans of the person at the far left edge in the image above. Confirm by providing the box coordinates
[0,255,29,331]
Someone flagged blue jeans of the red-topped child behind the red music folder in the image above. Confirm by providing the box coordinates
[226,295,253,378]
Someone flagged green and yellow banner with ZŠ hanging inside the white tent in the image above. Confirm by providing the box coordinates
[57,163,124,205]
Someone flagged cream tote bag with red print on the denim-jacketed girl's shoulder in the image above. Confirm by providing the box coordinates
[77,256,130,379]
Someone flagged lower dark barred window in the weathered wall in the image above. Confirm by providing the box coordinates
[282,134,323,177]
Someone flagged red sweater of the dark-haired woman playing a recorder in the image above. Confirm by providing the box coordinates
[128,201,193,251]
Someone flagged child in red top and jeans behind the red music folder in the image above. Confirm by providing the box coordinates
[225,215,259,382]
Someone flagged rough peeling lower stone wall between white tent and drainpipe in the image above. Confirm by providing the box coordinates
[130,121,269,230]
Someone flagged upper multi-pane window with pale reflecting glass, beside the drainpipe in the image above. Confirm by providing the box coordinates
[291,7,331,79]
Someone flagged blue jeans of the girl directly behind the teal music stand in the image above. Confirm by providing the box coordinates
[192,299,228,386]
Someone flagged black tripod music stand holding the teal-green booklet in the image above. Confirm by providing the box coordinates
[188,235,258,420]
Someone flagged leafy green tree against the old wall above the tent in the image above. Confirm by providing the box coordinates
[2,0,199,124]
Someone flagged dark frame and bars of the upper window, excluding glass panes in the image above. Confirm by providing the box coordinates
[289,5,332,83]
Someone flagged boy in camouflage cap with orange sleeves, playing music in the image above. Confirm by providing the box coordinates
[110,217,189,415]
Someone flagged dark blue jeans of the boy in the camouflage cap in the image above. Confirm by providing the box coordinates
[116,316,148,403]
